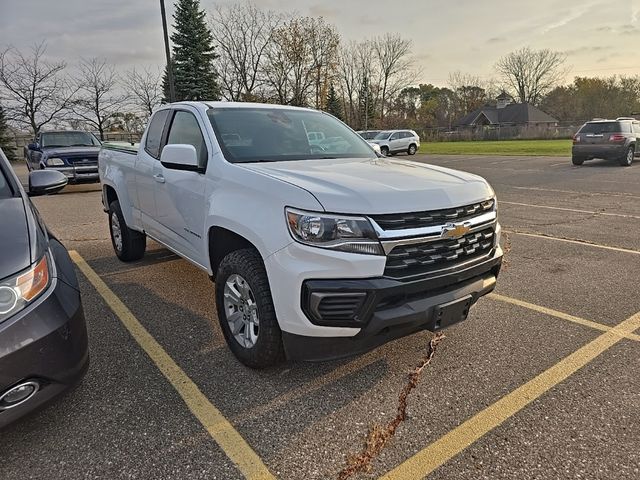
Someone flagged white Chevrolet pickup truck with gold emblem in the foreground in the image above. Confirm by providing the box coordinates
[99,102,502,368]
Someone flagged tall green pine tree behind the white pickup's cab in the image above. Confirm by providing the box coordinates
[163,0,220,101]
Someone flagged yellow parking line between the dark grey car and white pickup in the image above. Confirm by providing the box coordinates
[69,251,275,480]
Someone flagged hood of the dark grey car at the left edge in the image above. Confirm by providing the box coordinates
[0,197,31,279]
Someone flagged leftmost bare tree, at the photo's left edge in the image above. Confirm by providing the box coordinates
[0,42,75,134]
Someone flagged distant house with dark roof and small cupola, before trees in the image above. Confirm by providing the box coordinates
[456,91,558,129]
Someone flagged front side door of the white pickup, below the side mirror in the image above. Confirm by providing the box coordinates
[154,107,211,267]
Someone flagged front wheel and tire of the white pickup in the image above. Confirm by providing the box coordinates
[216,248,284,368]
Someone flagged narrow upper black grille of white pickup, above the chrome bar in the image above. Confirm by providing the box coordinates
[371,200,494,230]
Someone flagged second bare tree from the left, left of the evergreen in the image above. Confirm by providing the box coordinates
[71,58,127,140]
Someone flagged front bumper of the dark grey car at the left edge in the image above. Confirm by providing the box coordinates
[0,240,89,428]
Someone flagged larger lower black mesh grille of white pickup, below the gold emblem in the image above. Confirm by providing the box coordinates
[384,227,494,278]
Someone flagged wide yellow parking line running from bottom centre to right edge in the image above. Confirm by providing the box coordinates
[382,313,640,480]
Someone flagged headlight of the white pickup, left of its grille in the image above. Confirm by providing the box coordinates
[286,208,384,255]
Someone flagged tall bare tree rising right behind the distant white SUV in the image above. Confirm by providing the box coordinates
[373,33,415,122]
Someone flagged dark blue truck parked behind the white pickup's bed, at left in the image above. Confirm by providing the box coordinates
[25,130,100,183]
